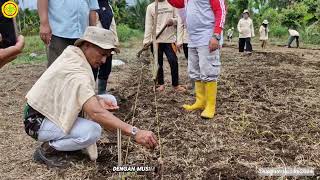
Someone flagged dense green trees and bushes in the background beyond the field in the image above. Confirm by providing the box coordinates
[18,0,320,44]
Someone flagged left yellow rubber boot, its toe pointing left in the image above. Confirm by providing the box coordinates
[183,81,206,111]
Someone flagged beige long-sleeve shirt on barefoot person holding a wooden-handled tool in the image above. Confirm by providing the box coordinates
[143,0,178,44]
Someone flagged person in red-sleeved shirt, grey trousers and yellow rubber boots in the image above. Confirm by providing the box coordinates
[168,0,227,119]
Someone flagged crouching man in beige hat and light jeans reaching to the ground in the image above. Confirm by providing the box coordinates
[24,27,157,167]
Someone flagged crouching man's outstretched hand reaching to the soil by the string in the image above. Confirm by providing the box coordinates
[135,130,158,149]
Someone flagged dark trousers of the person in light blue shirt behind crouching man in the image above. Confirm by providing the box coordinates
[47,35,77,67]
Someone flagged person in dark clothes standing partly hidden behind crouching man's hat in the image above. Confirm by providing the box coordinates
[93,0,120,94]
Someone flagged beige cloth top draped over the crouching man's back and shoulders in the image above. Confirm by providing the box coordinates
[26,46,95,134]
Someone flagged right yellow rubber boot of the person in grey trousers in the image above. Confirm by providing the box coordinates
[201,82,218,119]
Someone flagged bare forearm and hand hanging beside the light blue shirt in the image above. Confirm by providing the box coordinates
[37,0,52,45]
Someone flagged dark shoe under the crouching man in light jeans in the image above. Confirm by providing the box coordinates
[33,142,70,168]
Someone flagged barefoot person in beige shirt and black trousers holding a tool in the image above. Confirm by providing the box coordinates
[143,0,186,92]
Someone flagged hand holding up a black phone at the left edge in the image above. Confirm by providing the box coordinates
[0,35,24,68]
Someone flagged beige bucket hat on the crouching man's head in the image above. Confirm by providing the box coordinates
[74,26,116,49]
